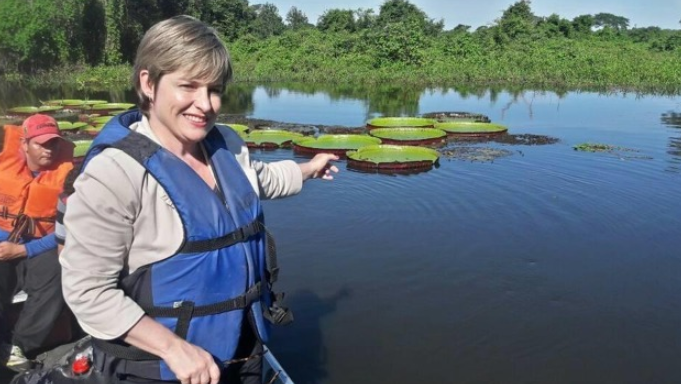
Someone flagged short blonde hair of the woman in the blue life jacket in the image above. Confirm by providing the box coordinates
[132,15,232,114]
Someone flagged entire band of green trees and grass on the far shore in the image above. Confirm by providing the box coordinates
[0,0,681,87]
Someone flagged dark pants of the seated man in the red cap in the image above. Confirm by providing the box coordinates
[0,249,64,355]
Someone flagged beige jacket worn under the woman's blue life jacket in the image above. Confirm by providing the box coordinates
[59,118,303,339]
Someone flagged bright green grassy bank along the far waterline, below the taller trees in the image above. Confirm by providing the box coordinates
[4,30,681,93]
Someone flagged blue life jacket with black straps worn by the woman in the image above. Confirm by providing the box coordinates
[83,110,292,380]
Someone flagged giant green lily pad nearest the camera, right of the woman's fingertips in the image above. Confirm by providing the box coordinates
[347,144,439,170]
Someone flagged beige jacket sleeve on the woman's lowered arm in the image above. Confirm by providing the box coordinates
[59,149,144,340]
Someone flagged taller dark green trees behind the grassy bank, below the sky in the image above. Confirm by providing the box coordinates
[0,0,681,86]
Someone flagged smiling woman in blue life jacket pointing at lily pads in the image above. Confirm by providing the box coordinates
[60,16,338,384]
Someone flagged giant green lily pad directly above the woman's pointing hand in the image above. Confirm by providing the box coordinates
[293,135,381,157]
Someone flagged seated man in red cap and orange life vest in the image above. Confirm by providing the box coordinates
[0,114,74,371]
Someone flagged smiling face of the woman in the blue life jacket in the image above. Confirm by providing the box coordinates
[140,71,223,144]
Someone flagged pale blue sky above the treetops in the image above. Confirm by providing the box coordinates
[262,0,681,30]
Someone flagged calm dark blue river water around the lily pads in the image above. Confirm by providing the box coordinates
[3,86,681,384]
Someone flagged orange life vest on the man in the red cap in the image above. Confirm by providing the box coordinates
[0,125,73,242]
